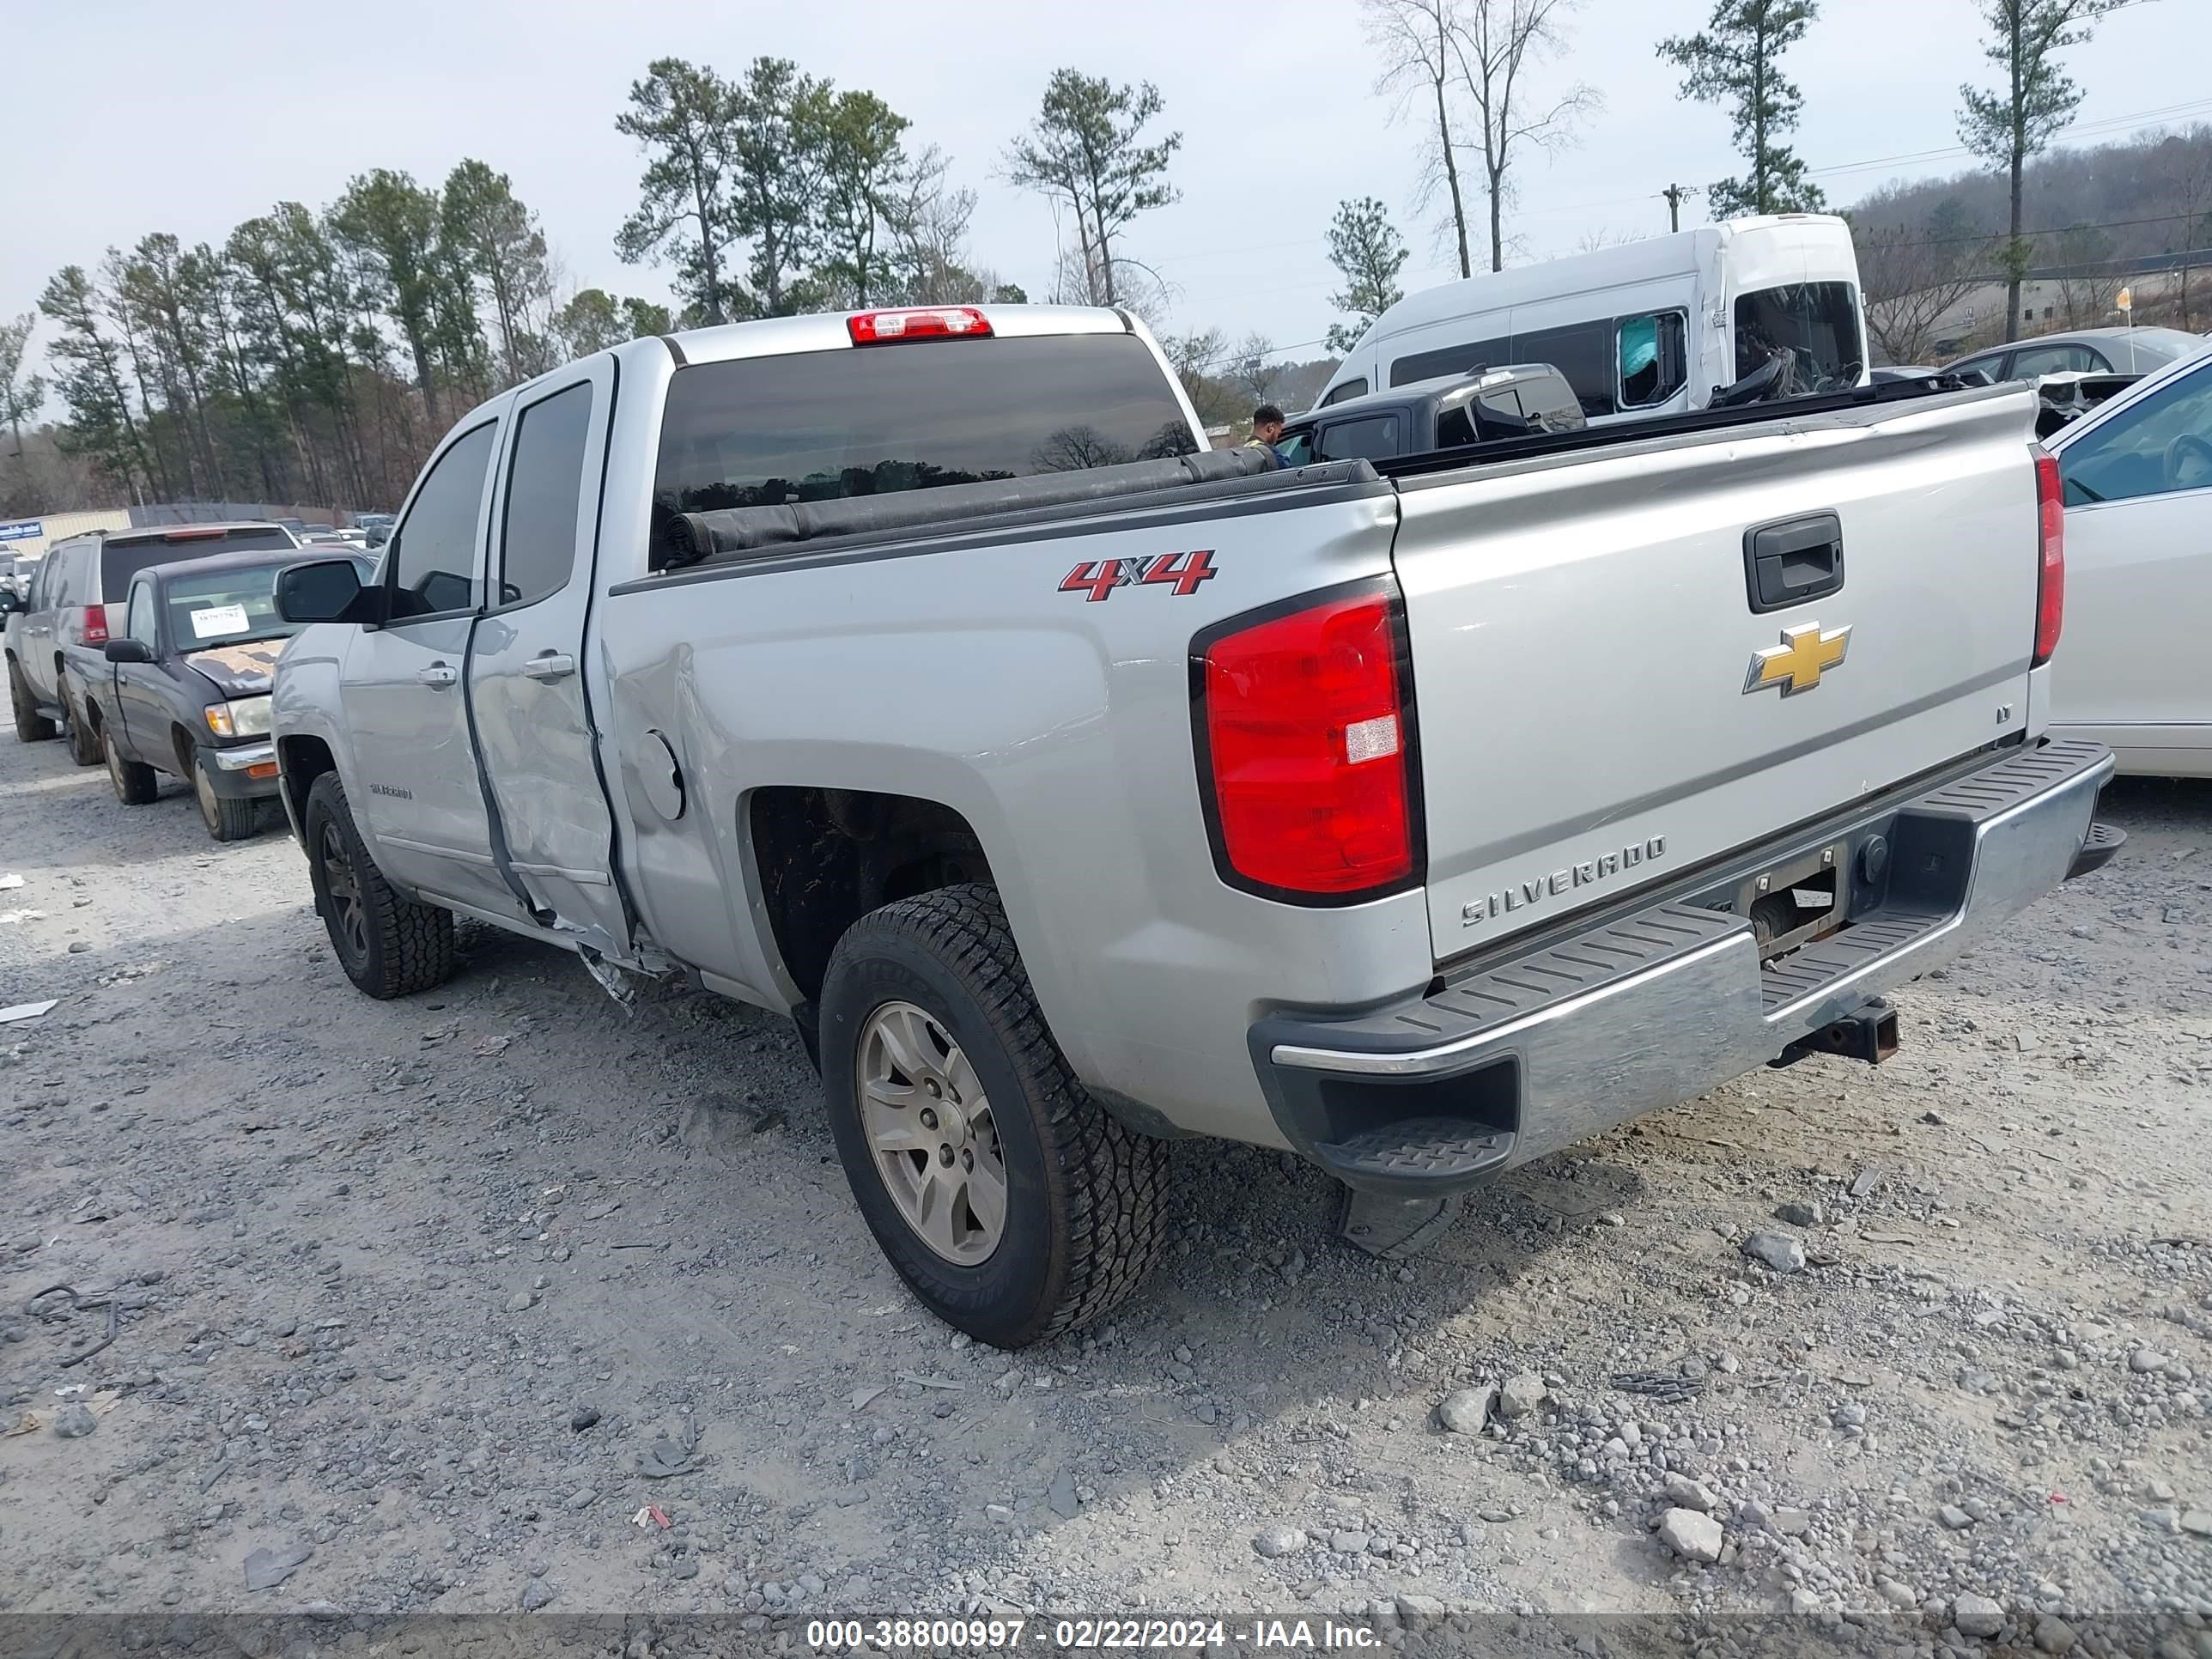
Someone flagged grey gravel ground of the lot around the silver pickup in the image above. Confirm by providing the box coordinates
[0,741,2212,1659]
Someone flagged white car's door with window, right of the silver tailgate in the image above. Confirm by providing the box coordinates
[2051,361,2212,748]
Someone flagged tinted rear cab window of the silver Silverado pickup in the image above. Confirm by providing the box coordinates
[653,334,1199,542]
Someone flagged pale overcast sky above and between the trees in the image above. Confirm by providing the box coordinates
[13,0,2212,375]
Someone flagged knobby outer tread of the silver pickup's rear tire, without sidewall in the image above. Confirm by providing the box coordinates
[832,883,1168,1343]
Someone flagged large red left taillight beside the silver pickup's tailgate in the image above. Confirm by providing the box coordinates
[1192,584,1420,902]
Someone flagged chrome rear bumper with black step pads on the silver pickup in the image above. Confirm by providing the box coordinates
[1252,744,2112,1194]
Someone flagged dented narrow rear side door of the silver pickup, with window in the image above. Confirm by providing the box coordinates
[469,354,629,956]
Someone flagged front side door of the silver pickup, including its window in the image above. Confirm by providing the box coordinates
[341,416,515,915]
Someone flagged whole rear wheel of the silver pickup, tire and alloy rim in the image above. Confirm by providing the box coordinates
[821,884,1168,1347]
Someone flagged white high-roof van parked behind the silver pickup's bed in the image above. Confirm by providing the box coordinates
[1314,212,1867,422]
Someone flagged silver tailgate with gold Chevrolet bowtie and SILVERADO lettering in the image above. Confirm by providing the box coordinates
[1394,387,2039,960]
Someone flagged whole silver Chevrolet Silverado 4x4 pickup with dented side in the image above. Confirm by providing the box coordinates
[274,307,2115,1347]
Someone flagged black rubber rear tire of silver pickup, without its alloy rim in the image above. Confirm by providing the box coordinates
[821,884,1168,1347]
